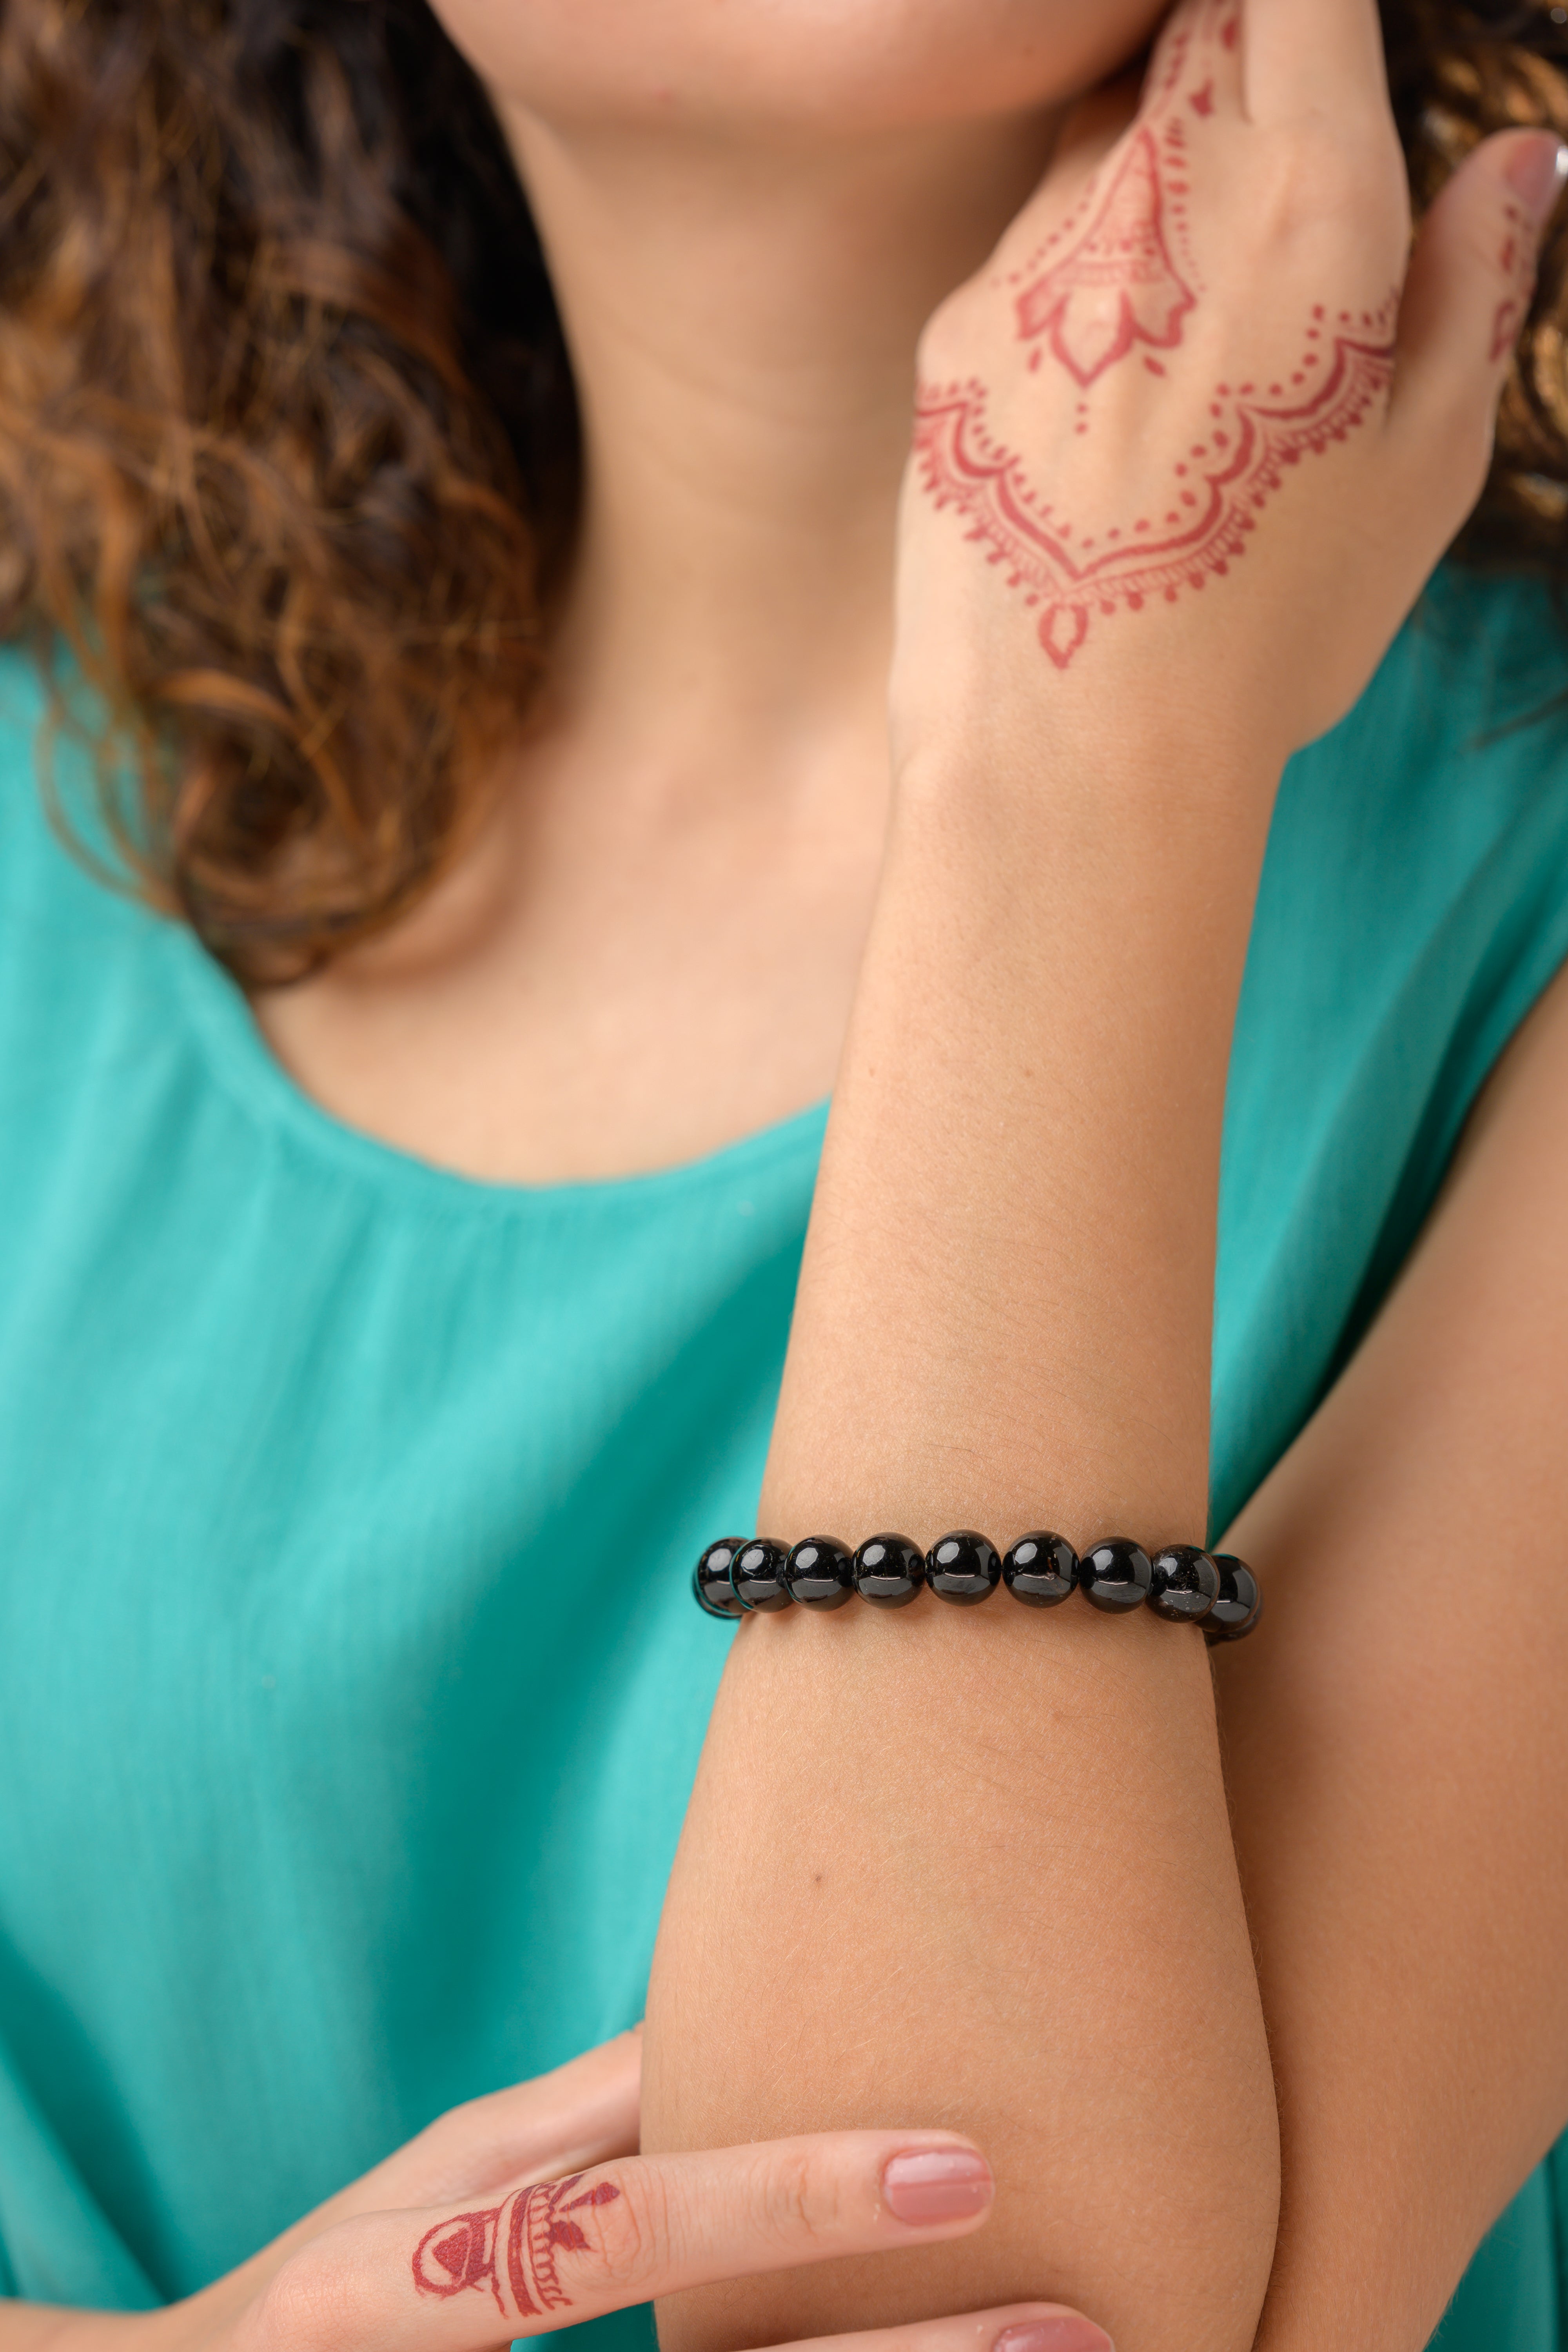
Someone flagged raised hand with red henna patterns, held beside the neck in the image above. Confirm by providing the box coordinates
[896,0,1561,757]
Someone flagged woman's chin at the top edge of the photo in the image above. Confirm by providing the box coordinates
[423,0,1166,136]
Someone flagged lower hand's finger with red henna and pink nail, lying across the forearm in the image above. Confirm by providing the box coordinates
[259,2131,992,2352]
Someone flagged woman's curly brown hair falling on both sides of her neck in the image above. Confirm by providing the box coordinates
[0,0,1568,983]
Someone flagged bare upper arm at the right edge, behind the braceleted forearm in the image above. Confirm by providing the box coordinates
[1218,955,1568,2352]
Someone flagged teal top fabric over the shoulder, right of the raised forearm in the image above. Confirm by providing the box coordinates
[1215,572,1568,1517]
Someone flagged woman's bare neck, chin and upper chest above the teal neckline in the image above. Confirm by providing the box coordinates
[259,0,1154,1183]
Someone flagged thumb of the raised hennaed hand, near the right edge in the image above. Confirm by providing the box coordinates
[1389,129,1568,473]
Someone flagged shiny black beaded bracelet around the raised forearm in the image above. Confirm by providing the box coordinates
[691,1526,1262,1642]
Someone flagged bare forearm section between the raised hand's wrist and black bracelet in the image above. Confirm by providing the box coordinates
[764,706,1274,1541]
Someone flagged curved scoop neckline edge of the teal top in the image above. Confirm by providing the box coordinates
[167,924,828,1216]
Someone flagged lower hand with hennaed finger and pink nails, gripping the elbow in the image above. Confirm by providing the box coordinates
[120,2034,1110,2352]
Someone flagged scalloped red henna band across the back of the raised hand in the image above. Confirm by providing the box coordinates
[915,303,1394,670]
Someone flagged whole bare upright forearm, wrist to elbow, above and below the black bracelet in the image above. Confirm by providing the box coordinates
[644,715,1276,2352]
